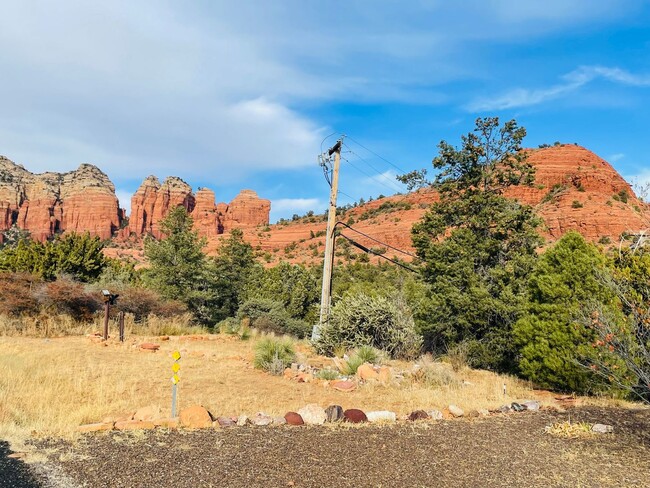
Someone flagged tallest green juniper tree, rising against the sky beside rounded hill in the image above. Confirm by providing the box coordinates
[401,118,541,371]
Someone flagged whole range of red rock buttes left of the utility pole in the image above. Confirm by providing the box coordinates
[0,156,271,241]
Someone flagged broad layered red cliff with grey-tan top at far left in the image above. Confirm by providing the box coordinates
[0,156,121,241]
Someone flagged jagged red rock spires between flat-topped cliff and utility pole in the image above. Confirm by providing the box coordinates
[129,176,271,240]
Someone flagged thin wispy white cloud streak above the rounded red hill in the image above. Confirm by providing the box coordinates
[465,66,650,112]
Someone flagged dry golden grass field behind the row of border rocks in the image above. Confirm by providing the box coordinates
[0,335,636,452]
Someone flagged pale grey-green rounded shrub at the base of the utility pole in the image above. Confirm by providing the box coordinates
[314,293,422,358]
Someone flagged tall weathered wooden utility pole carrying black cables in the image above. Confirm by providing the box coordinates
[311,138,343,341]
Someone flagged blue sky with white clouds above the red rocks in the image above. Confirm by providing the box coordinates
[0,0,650,221]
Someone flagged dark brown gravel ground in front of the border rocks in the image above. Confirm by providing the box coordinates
[5,408,650,488]
